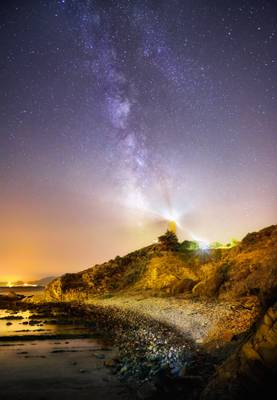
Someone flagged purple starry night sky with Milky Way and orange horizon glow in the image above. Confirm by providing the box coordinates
[0,0,277,279]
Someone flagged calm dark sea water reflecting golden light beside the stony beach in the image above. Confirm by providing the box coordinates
[0,286,134,400]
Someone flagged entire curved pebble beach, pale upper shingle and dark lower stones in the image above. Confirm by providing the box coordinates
[0,293,274,400]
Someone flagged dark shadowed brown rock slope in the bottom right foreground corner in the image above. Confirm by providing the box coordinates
[201,303,277,400]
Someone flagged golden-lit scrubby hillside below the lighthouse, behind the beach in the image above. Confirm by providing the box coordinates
[46,225,277,305]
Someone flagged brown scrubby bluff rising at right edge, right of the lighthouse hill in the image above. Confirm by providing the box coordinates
[193,225,277,305]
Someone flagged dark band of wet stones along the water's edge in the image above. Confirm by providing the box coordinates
[0,299,222,399]
